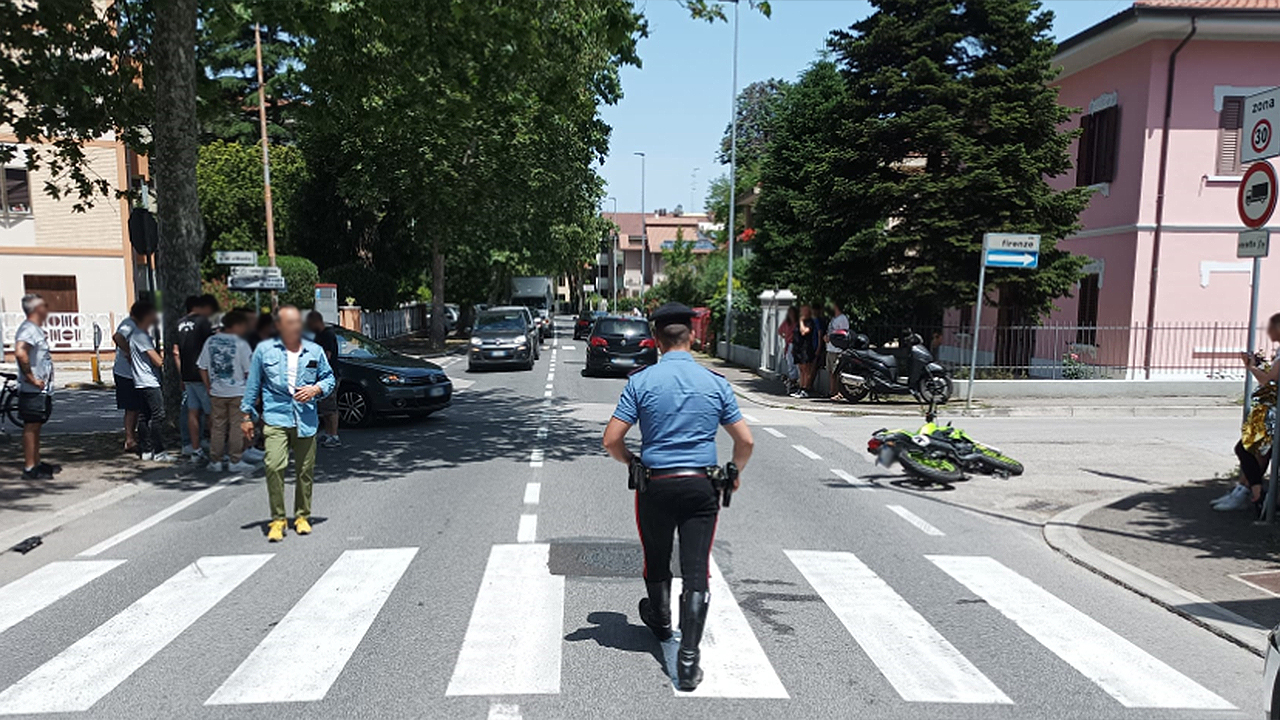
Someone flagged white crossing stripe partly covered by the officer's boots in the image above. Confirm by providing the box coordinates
[663,557,790,698]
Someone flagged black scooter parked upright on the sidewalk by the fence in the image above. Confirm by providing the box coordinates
[831,331,952,405]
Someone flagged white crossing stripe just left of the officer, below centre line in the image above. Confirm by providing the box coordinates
[444,543,564,696]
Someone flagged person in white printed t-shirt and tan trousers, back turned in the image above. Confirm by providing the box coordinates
[196,310,255,473]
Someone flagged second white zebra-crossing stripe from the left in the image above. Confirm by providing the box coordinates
[0,555,271,715]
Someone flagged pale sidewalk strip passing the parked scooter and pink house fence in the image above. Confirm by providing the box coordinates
[695,354,1242,418]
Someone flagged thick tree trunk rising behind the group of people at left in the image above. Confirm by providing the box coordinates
[148,0,204,429]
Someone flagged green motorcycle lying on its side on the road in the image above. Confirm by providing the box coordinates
[867,404,1023,484]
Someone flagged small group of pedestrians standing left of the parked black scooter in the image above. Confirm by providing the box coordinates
[778,297,850,398]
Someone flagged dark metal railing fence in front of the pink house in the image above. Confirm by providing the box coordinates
[858,317,1271,379]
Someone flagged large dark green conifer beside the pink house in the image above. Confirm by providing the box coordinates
[756,0,1088,323]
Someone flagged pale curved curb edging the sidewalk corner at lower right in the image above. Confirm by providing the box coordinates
[1042,493,1267,657]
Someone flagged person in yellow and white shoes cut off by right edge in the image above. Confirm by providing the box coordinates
[1212,313,1280,512]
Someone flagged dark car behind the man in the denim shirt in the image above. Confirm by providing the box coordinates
[333,327,453,428]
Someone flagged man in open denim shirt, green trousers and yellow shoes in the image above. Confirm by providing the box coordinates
[241,305,334,542]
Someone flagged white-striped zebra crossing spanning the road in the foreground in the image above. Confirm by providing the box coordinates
[0,542,1234,715]
